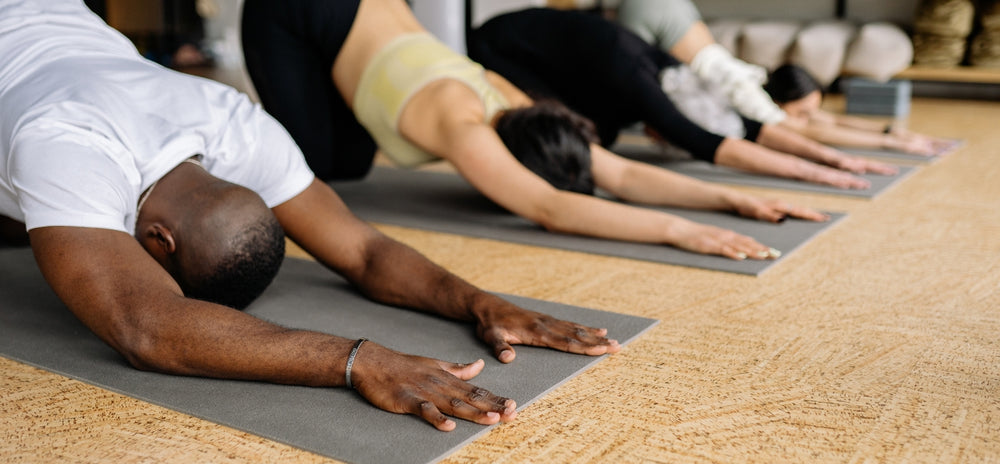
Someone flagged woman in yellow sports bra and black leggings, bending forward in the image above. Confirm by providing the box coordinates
[243,0,826,259]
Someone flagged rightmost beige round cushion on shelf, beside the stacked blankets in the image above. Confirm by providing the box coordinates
[844,22,913,81]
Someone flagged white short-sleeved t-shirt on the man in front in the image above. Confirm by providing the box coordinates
[0,0,313,234]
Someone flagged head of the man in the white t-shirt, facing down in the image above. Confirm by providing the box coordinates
[135,158,285,309]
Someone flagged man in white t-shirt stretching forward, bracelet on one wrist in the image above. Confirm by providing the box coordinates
[0,0,619,430]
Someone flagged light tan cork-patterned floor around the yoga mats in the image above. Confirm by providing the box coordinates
[0,95,1000,463]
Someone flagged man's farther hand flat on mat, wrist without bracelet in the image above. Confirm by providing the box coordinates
[475,304,621,363]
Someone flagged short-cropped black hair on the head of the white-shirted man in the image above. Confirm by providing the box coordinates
[182,214,285,310]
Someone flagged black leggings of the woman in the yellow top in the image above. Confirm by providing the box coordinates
[243,0,376,180]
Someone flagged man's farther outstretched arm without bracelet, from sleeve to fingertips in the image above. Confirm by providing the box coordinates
[274,180,619,362]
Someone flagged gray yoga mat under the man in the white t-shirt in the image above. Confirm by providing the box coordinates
[0,249,657,464]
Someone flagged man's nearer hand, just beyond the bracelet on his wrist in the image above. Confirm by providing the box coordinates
[351,343,517,432]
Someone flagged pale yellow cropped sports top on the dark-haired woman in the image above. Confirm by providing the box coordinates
[354,33,510,167]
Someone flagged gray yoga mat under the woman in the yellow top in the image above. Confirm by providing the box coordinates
[331,168,843,275]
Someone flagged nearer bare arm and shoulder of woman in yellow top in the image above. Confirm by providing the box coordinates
[399,80,770,259]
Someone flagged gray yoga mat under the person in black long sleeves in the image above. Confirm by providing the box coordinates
[612,144,916,199]
